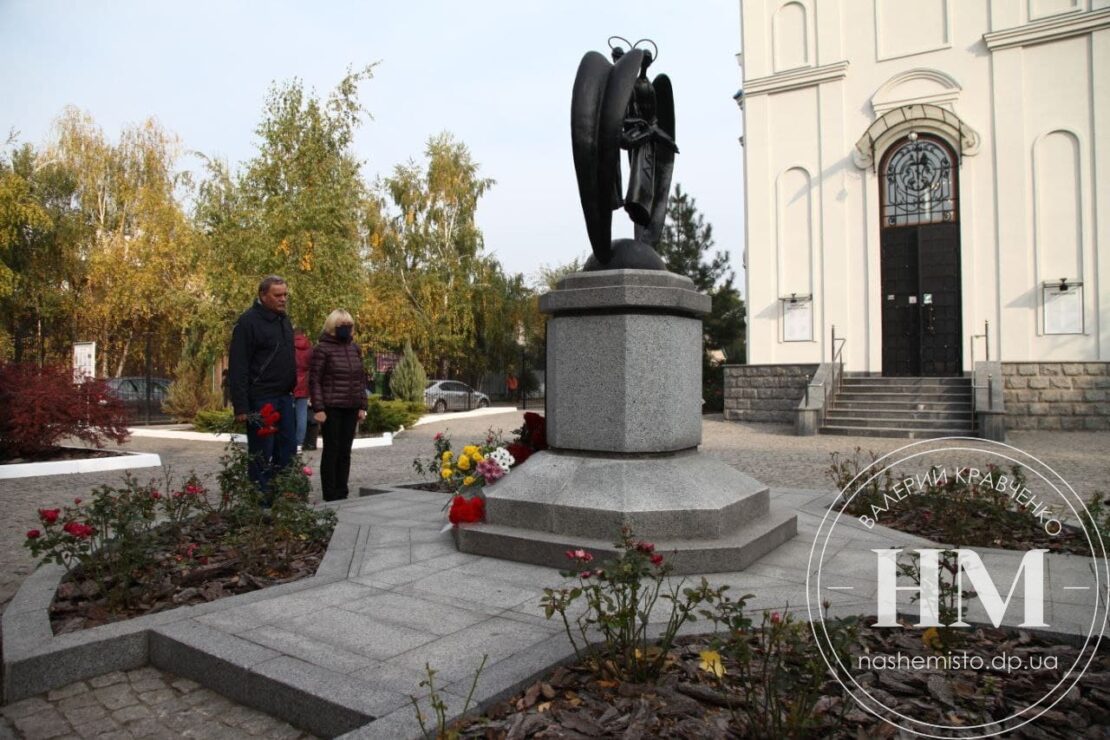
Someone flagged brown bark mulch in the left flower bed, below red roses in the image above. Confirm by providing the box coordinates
[50,516,327,635]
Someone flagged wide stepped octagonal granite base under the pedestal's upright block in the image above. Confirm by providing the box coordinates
[455,450,797,574]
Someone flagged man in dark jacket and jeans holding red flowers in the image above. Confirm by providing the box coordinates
[228,275,296,499]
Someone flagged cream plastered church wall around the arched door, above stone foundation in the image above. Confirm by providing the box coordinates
[741,0,1110,372]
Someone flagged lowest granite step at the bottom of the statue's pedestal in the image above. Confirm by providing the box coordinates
[453,501,798,576]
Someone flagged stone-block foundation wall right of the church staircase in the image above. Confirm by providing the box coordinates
[1003,363,1110,429]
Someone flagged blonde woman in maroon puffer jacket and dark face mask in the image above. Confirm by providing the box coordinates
[309,308,366,501]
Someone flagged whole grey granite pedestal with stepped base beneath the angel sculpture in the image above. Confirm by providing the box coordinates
[455,270,797,574]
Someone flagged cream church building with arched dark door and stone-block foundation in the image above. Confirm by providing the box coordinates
[726,0,1110,436]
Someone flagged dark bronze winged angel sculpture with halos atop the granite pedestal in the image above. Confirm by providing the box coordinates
[571,37,678,271]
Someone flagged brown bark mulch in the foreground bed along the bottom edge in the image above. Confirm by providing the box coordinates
[455,628,1110,740]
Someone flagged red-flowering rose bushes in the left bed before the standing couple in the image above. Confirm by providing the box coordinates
[23,445,335,611]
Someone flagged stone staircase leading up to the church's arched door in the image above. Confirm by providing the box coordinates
[820,374,977,439]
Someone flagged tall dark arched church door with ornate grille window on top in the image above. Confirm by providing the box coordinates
[880,134,963,376]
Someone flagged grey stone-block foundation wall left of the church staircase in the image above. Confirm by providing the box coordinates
[724,364,817,424]
